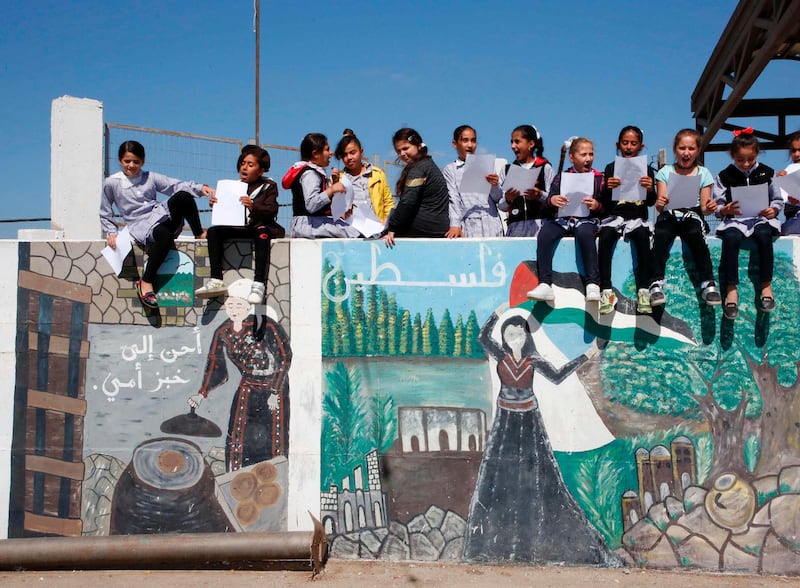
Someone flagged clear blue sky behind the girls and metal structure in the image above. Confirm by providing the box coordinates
[0,0,800,237]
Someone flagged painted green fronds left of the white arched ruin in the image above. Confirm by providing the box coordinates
[321,362,397,490]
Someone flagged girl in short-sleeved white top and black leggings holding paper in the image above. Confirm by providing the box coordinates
[650,129,722,306]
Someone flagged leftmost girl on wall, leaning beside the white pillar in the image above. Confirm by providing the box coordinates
[100,141,214,309]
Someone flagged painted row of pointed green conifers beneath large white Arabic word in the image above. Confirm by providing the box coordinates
[322,261,483,357]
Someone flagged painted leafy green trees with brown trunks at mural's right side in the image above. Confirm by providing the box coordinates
[601,248,800,477]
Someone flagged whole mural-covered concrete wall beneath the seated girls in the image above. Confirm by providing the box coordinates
[0,234,800,574]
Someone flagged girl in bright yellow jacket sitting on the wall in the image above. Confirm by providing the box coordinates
[331,129,394,237]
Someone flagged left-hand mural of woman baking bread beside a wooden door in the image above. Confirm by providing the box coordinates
[9,241,292,537]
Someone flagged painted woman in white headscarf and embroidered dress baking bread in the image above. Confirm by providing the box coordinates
[187,279,292,471]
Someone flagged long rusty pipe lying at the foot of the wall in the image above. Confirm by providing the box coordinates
[0,517,327,575]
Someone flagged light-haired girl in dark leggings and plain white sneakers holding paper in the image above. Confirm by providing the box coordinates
[528,137,603,302]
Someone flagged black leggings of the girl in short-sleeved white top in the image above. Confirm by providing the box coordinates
[650,215,714,284]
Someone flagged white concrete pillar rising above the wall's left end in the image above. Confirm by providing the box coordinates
[50,96,103,240]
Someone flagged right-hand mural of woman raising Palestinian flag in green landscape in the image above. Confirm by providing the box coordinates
[320,239,800,573]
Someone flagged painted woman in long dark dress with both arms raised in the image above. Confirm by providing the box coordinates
[464,311,611,564]
